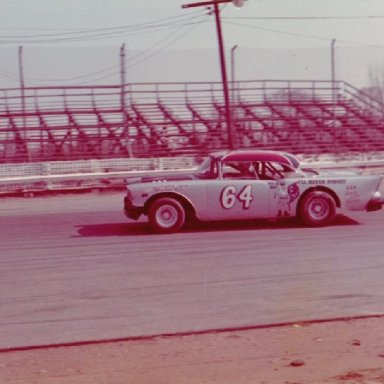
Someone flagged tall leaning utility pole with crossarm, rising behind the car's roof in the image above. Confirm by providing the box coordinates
[182,0,244,149]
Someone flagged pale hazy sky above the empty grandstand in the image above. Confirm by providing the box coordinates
[0,0,384,88]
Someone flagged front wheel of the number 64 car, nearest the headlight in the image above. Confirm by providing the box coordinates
[148,198,185,233]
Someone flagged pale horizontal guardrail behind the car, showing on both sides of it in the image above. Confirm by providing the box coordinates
[0,154,384,196]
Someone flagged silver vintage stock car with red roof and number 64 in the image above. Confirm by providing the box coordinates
[124,150,384,233]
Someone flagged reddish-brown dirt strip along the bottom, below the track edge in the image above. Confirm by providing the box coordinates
[0,317,384,384]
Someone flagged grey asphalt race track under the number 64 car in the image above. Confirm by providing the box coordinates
[0,193,384,349]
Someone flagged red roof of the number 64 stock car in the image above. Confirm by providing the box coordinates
[212,149,300,168]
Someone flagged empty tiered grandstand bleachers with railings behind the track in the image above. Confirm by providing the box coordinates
[0,81,384,163]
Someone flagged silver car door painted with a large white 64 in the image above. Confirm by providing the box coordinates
[199,179,276,220]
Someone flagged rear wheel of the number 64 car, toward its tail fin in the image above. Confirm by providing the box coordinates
[298,191,336,227]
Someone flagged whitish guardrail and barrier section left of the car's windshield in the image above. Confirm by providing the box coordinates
[0,157,197,196]
